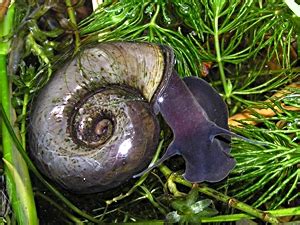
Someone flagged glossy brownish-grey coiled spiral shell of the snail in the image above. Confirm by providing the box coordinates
[29,42,173,193]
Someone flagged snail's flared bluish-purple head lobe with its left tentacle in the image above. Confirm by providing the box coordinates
[134,126,236,183]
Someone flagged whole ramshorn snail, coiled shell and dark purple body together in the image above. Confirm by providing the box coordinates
[29,42,235,193]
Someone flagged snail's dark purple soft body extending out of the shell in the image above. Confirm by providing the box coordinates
[134,72,235,183]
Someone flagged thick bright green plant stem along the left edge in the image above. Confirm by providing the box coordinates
[0,3,38,225]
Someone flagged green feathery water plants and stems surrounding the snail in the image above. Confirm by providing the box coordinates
[0,0,300,224]
